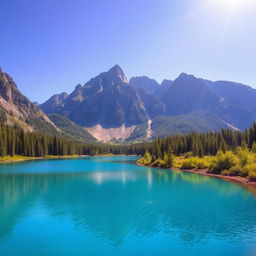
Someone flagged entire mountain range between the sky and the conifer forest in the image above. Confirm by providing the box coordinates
[0,65,256,142]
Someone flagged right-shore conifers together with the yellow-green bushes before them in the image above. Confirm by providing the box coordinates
[138,123,256,182]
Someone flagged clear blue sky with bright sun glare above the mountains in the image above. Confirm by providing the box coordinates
[0,0,256,103]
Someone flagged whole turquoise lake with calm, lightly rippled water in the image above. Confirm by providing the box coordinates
[0,157,256,256]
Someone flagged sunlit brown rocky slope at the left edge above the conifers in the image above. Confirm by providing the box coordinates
[0,66,58,132]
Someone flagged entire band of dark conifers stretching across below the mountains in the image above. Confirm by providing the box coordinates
[0,123,256,159]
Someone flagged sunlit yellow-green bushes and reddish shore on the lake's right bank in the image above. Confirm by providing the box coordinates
[137,147,256,184]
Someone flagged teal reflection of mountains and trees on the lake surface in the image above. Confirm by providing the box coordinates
[0,157,256,245]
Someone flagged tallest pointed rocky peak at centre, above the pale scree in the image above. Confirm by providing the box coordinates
[40,66,147,128]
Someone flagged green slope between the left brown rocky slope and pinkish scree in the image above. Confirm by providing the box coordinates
[48,114,96,141]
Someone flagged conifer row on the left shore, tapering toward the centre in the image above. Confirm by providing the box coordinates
[0,123,140,157]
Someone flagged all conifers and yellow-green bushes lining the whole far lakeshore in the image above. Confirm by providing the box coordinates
[0,119,256,181]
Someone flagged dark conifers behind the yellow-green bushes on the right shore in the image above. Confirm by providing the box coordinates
[143,123,256,159]
